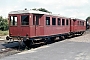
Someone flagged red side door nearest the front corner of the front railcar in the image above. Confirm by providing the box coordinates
[33,14,43,36]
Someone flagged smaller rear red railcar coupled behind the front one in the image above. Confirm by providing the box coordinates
[71,19,86,34]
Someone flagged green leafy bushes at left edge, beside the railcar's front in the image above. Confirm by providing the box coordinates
[0,16,8,31]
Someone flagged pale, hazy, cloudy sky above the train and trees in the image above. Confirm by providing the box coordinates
[0,0,90,20]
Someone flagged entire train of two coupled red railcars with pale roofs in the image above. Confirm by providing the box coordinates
[6,10,86,47]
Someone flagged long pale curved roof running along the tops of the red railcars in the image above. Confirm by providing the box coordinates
[9,10,85,20]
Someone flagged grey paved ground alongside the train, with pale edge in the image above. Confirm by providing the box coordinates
[0,31,90,60]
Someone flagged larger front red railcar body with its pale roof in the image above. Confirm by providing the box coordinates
[9,10,70,37]
